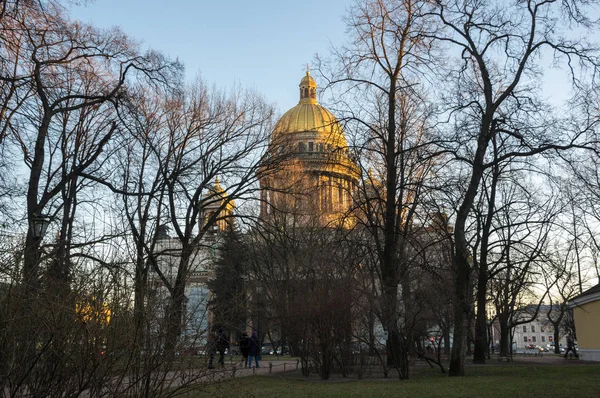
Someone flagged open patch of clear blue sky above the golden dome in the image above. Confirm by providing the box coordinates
[70,0,354,111]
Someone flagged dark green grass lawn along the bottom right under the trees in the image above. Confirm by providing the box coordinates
[198,365,600,398]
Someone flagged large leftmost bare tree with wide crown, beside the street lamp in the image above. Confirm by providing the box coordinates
[1,2,176,390]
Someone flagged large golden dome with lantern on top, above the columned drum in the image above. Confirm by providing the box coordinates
[272,71,348,147]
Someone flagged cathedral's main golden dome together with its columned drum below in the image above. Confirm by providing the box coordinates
[260,71,360,226]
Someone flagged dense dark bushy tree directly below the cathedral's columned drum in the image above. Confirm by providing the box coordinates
[248,204,362,380]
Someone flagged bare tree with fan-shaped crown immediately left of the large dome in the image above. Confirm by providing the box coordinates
[156,81,272,350]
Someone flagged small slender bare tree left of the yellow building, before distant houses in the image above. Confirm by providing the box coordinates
[486,171,560,356]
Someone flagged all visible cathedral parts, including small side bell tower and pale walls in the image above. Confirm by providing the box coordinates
[154,71,360,348]
